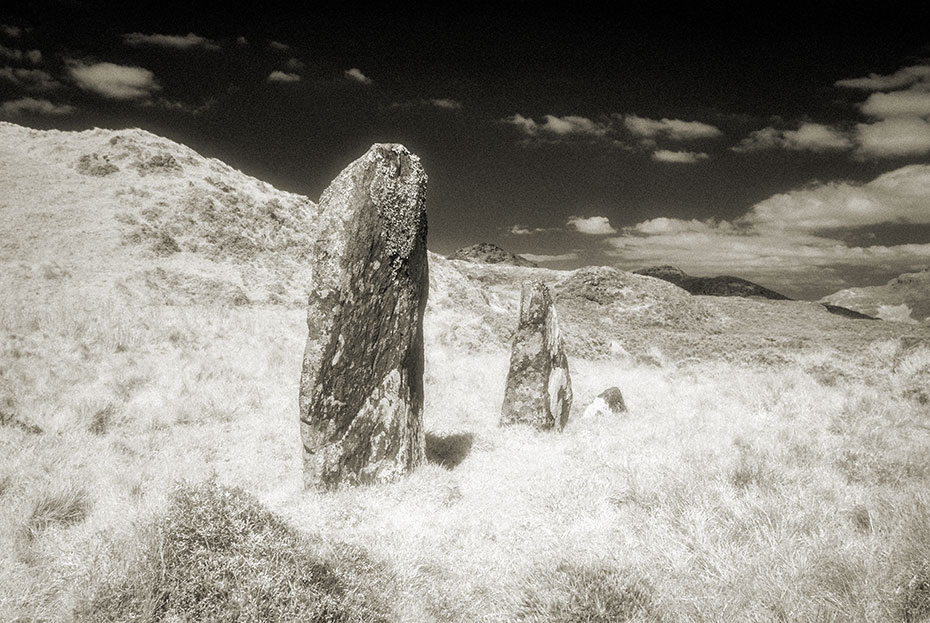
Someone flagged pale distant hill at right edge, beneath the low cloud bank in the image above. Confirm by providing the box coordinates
[820,270,930,323]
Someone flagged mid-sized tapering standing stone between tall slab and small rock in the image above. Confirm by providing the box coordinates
[501,281,572,430]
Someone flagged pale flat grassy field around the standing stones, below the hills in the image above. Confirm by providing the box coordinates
[0,286,930,622]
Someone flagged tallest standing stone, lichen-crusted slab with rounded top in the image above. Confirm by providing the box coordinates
[300,144,429,488]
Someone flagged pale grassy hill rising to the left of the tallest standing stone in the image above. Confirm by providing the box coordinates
[0,123,316,304]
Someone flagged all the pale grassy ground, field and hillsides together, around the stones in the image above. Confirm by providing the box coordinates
[0,124,930,623]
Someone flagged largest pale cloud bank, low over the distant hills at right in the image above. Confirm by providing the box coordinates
[607,165,930,297]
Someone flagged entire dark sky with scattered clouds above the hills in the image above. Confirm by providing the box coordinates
[0,2,930,297]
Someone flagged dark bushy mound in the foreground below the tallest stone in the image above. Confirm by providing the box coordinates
[75,482,385,623]
